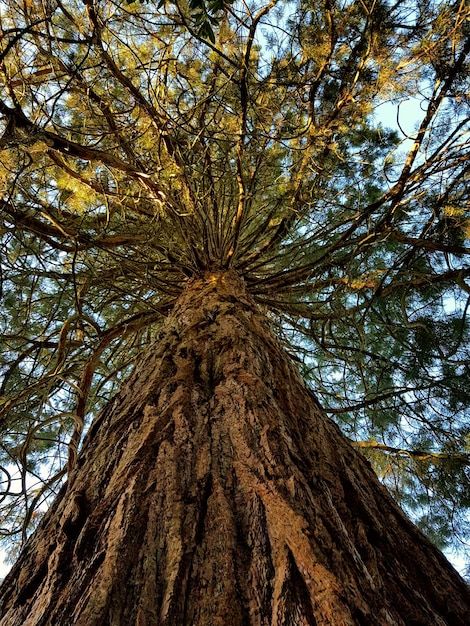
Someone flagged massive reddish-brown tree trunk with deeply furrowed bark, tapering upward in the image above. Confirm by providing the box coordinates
[0,272,470,626]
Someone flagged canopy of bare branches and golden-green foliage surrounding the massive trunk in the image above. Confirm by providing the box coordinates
[0,0,470,564]
